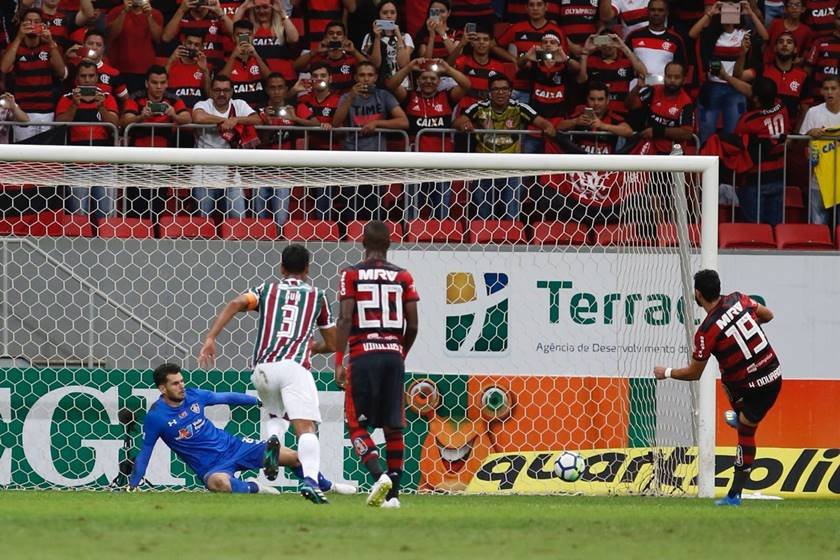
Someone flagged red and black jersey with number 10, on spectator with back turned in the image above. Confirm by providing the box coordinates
[735,102,793,182]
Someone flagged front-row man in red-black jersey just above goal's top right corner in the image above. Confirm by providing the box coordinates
[627,62,694,155]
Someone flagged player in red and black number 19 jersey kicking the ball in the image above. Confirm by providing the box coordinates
[653,270,782,506]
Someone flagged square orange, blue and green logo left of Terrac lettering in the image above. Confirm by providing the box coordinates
[445,272,510,356]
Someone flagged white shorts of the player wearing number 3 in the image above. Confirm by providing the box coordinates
[251,360,321,422]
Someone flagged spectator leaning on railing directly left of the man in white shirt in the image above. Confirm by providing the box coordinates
[120,65,192,220]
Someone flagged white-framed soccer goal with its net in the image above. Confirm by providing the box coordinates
[0,145,718,496]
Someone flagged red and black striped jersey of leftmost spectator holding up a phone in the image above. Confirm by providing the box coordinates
[11,43,55,113]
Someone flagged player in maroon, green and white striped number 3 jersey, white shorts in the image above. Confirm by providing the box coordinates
[198,245,355,504]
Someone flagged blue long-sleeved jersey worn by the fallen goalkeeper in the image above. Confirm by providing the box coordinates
[129,388,259,487]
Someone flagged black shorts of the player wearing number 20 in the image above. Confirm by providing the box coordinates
[345,352,405,428]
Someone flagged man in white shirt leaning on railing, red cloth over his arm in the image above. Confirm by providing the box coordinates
[193,74,262,218]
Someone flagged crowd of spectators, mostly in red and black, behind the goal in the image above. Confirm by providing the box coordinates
[0,0,840,233]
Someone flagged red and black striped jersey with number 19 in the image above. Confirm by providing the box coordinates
[693,292,779,389]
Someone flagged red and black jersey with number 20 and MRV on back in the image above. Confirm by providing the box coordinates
[338,259,420,359]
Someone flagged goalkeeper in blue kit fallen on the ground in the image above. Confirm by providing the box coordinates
[129,364,331,494]
